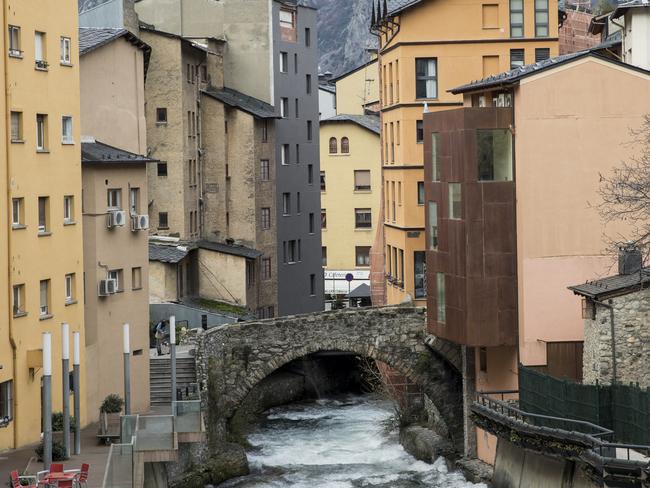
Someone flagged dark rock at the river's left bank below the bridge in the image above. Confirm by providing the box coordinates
[169,443,249,488]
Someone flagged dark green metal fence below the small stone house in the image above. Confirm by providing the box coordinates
[519,366,650,445]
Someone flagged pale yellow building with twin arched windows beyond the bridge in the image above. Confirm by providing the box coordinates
[320,114,381,295]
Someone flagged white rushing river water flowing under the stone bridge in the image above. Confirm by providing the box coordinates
[220,396,485,488]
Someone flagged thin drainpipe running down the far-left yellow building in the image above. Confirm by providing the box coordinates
[0,0,20,449]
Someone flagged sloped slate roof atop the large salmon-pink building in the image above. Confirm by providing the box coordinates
[449,51,650,94]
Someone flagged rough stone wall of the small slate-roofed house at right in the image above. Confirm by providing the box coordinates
[583,289,650,387]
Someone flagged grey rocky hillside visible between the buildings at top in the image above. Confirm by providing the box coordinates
[311,0,376,75]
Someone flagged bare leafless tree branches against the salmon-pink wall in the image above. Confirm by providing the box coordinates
[598,115,650,251]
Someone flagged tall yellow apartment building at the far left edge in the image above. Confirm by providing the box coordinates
[0,0,86,451]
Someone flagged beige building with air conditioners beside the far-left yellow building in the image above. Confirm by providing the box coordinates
[79,28,154,419]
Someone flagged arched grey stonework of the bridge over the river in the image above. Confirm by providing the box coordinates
[196,307,463,451]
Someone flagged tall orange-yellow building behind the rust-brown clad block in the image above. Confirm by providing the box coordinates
[372,0,559,306]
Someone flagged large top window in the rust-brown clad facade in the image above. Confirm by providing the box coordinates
[476,129,512,181]
